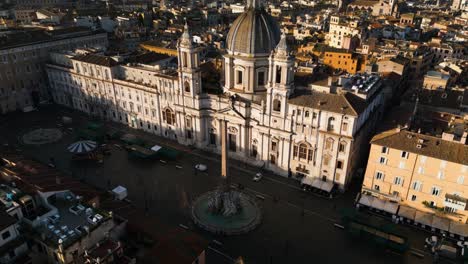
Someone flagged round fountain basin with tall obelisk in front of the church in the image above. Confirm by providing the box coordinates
[192,120,261,235]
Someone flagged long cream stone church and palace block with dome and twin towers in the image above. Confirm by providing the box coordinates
[47,1,384,190]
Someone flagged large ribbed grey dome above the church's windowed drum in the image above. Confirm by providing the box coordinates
[226,0,281,55]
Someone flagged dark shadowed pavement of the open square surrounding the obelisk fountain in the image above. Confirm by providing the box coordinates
[0,107,438,263]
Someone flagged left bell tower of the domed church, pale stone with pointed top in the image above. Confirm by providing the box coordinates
[177,22,201,97]
